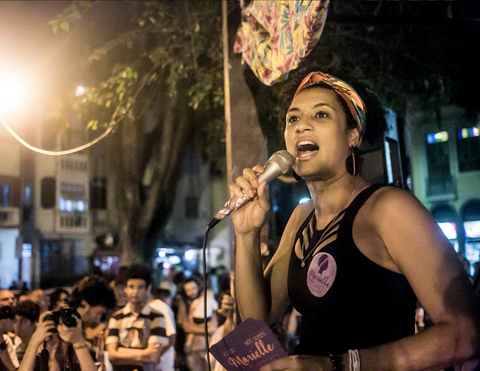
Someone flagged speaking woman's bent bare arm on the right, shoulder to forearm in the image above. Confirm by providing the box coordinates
[360,189,480,370]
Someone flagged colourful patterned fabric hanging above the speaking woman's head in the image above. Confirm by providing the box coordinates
[234,0,330,86]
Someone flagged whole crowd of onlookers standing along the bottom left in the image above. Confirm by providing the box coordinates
[0,264,233,371]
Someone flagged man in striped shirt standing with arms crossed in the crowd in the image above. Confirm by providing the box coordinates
[105,264,169,371]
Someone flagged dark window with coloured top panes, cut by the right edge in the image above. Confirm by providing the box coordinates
[457,127,480,172]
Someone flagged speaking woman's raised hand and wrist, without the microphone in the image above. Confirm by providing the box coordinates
[230,165,270,234]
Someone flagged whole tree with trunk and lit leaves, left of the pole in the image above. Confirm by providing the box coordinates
[50,1,224,263]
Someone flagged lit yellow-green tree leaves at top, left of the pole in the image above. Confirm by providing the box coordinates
[50,1,223,161]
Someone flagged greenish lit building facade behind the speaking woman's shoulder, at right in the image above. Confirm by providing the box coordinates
[406,106,480,274]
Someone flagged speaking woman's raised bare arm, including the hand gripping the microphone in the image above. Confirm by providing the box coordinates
[230,167,304,324]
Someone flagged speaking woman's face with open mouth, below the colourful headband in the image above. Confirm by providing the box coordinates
[285,87,356,181]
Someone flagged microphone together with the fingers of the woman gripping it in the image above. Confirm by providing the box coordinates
[208,150,295,228]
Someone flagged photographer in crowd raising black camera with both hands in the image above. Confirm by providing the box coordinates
[19,312,97,371]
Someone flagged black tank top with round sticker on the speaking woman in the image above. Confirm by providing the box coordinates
[288,185,416,355]
